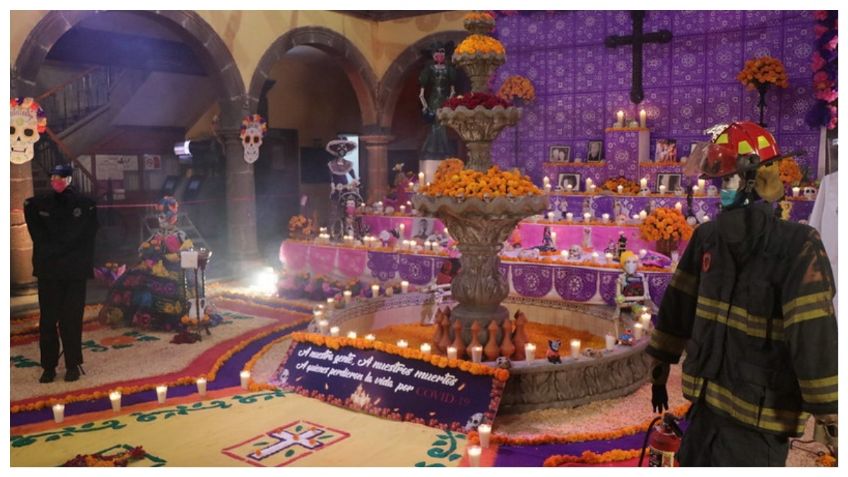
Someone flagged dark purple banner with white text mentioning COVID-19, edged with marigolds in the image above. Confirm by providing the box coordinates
[271,333,509,432]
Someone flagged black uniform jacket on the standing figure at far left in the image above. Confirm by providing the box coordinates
[24,187,98,280]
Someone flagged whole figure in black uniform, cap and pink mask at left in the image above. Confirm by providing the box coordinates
[24,164,98,383]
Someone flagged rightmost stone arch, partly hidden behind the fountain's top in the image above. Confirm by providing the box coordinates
[377,30,468,130]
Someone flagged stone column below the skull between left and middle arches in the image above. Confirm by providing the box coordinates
[220,130,261,272]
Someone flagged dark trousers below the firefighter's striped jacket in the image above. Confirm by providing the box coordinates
[677,402,789,467]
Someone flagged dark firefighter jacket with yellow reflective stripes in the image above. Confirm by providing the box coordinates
[647,202,837,436]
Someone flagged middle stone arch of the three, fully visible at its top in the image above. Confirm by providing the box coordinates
[247,26,377,125]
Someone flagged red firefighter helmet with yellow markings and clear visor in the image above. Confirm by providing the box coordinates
[685,121,797,177]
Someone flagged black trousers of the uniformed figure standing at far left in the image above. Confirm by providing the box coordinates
[38,279,85,369]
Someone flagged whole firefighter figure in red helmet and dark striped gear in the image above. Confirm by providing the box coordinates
[647,122,838,467]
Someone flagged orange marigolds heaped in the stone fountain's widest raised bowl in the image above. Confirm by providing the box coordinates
[421,158,542,199]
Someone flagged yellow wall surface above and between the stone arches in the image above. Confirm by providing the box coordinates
[10,10,465,88]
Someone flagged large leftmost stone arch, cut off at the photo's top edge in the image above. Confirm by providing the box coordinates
[15,10,245,129]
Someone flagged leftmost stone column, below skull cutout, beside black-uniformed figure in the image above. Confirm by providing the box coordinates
[9,161,37,295]
